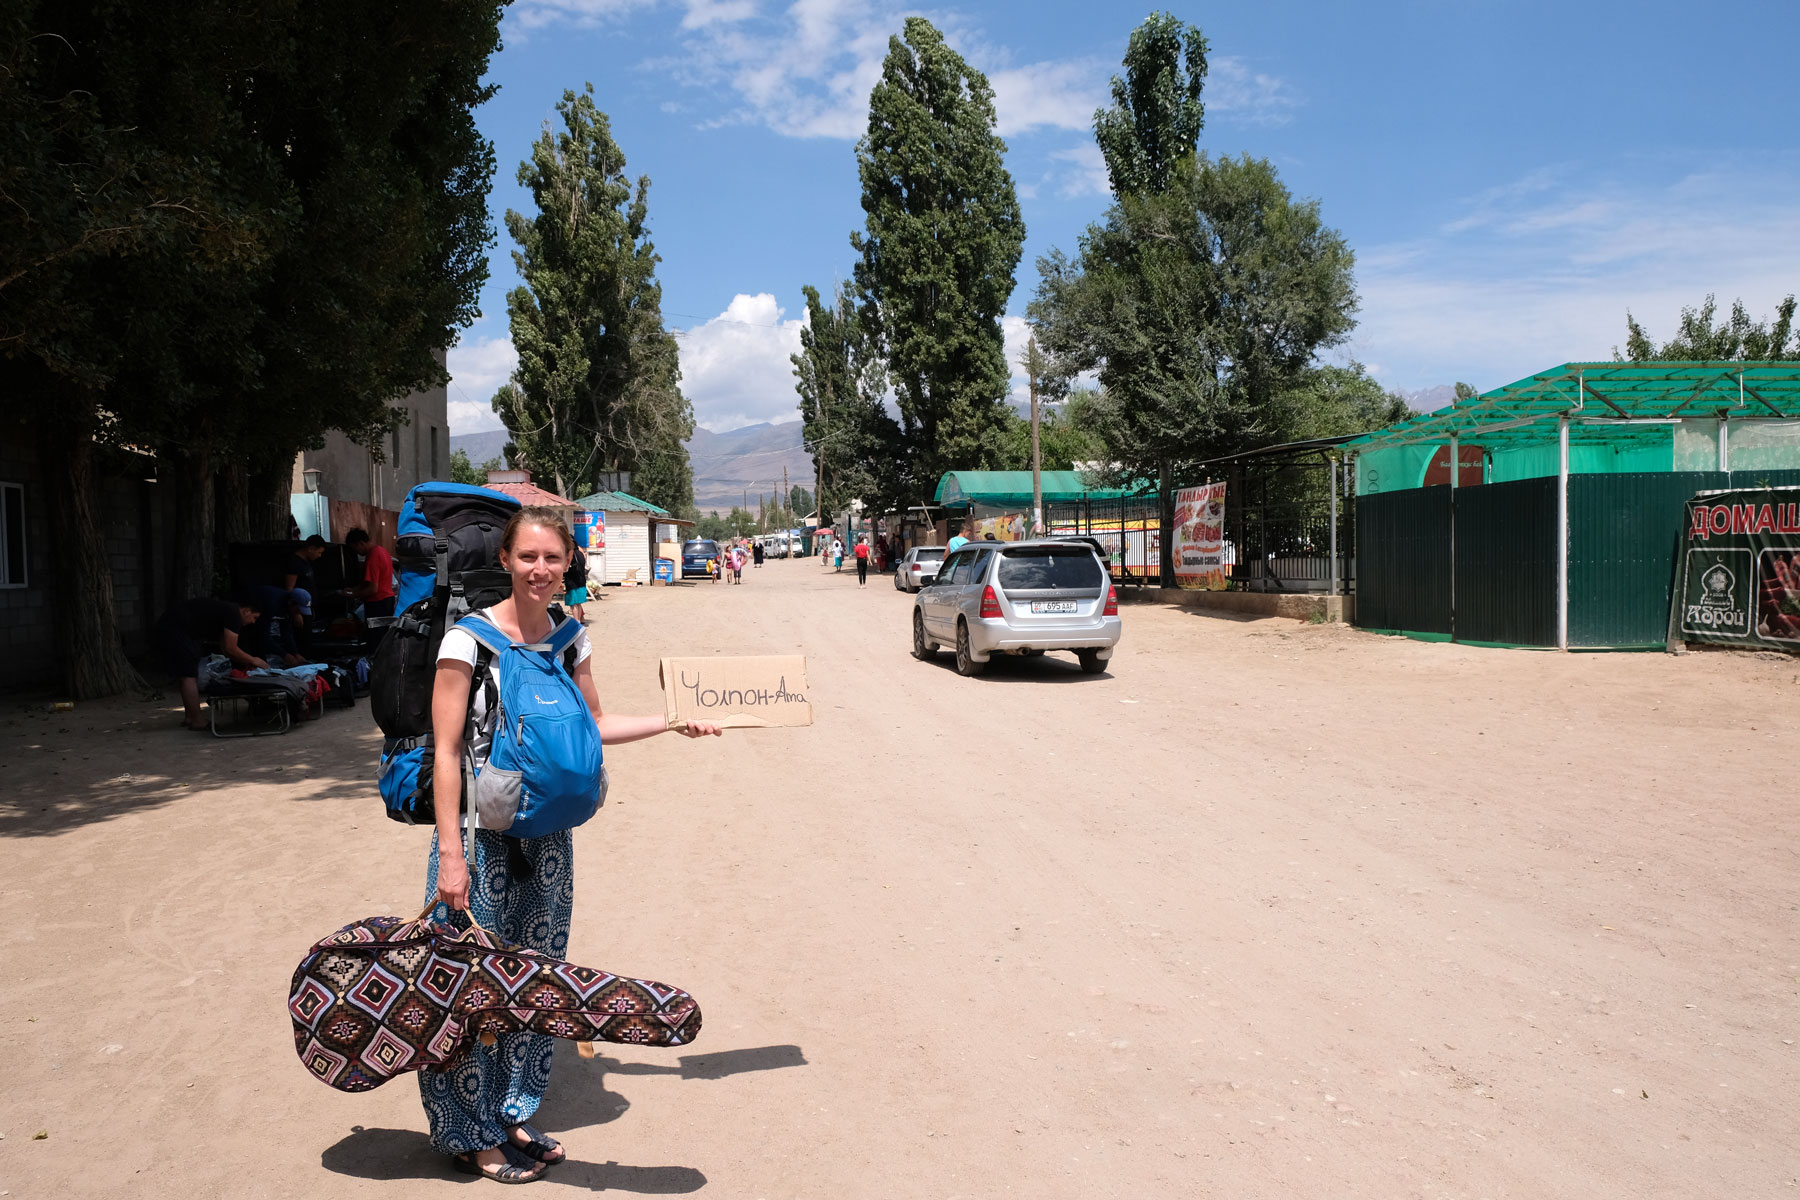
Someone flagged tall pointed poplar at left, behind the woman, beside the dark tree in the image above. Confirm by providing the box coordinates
[493,85,693,511]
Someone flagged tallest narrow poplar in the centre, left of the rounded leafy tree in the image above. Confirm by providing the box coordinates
[850,16,1024,495]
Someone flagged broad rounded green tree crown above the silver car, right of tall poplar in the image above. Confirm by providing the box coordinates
[1030,155,1355,489]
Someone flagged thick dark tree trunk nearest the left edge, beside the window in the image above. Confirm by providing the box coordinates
[38,394,146,700]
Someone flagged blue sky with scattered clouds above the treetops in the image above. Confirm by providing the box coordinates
[450,0,1800,434]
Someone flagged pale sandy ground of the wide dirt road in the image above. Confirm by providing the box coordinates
[0,561,1800,1200]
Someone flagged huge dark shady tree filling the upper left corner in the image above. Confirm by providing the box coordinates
[0,0,499,696]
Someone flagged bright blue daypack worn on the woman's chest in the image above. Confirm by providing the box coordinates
[457,615,607,838]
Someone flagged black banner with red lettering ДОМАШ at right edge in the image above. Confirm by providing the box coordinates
[1670,488,1800,651]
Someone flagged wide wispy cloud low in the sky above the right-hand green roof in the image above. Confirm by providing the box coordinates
[1350,157,1800,389]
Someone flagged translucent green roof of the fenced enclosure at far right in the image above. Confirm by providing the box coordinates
[1345,362,1800,453]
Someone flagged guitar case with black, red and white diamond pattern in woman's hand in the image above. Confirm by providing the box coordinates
[288,910,700,1092]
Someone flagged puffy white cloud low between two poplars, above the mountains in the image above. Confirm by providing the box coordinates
[675,291,806,434]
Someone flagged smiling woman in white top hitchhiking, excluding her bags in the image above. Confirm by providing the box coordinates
[419,507,720,1184]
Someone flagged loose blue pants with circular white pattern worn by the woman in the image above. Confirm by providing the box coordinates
[419,829,574,1153]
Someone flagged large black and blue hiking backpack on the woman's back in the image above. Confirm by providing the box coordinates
[369,482,518,824]
